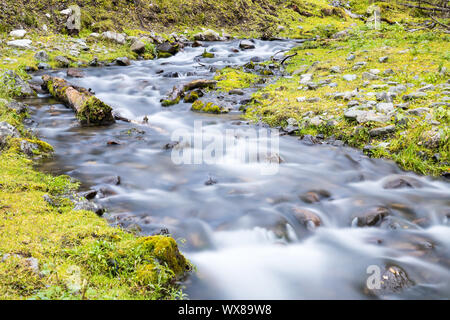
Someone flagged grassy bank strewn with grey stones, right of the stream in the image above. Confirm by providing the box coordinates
[246,24,450,175]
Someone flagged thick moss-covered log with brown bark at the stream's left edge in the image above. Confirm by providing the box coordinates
[42,74,115,125]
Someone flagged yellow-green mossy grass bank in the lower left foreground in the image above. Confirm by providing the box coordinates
[0,93,189,299]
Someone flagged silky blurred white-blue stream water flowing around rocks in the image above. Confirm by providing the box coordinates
[22,41,450,299]
